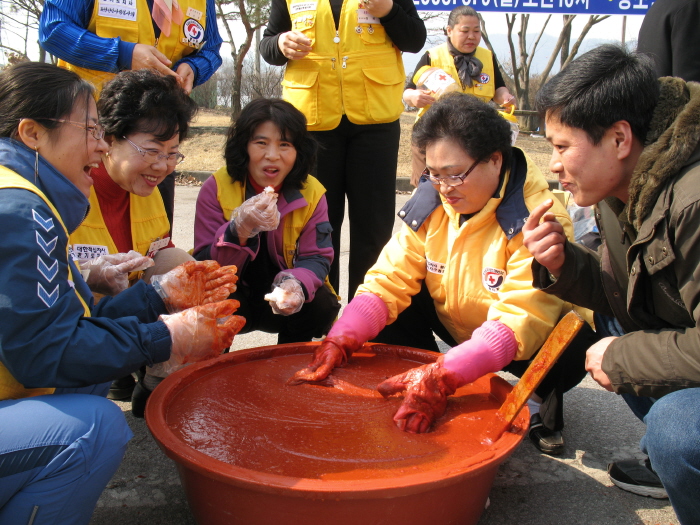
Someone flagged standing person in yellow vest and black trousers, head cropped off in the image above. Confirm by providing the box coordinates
[260,0,426,296]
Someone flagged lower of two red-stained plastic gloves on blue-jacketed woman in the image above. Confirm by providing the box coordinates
[147,299,245,377]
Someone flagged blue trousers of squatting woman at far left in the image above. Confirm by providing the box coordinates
[0,383,133,525]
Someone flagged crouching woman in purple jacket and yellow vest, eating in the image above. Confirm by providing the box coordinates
[194,99,340,344]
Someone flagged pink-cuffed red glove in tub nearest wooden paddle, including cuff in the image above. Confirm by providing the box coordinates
[377,321,518,434]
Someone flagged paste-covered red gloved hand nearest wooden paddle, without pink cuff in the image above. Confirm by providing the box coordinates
[377,356,463,434]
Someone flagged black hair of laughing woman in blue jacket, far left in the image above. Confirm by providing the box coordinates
[0,62,95,137]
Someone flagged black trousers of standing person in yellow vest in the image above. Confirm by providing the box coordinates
[312,115,401,299]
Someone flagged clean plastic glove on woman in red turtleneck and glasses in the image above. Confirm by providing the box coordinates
[80,250,155,295]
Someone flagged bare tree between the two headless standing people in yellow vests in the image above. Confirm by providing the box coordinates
[216,0,270,119]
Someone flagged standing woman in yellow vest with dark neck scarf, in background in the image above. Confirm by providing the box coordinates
[403,6,516,186]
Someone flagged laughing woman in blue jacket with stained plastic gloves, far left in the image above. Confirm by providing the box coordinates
[0,62,241,525]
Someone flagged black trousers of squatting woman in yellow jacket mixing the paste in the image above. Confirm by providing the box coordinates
[374,285,601,430]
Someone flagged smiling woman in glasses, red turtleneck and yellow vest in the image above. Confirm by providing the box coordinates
[70,70,196,399]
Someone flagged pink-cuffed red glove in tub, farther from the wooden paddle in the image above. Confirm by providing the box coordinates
[288,293,389,385]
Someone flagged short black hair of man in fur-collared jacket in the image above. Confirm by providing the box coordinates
[535,44,659,144]
